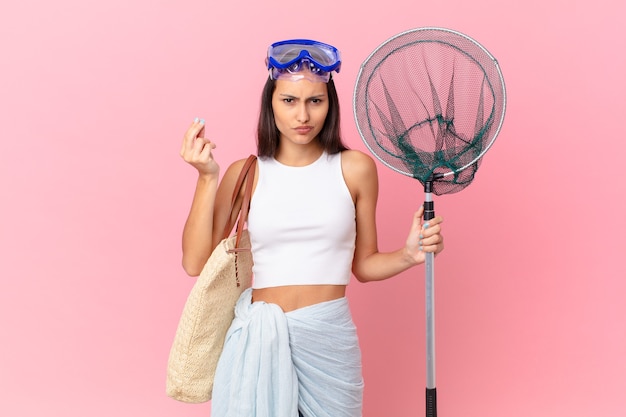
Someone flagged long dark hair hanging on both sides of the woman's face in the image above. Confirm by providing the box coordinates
[257,77,348,157]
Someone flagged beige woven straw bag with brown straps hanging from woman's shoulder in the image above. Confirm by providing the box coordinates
[166,155,256,403]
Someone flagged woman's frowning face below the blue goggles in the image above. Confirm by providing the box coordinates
[272,79,328,145]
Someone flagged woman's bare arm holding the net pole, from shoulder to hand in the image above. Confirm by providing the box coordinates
[342,151,443,282]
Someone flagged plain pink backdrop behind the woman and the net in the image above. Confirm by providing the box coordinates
[0,0,626,417]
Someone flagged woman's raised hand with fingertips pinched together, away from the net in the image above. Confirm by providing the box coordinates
[180,118,220,177]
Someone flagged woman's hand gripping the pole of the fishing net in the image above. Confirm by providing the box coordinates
[406,207,443,263]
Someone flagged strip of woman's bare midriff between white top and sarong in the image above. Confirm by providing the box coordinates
[252,285,346,313]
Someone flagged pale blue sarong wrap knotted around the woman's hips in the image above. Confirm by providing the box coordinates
[211,289,363,417]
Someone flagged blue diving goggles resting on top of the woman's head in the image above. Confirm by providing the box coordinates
[266,39,341,83]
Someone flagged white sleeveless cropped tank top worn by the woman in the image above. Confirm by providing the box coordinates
[248,152,356,288]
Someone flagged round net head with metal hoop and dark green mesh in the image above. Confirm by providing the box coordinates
[354,28,505,195]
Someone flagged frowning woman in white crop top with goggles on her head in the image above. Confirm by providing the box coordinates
[181,39,443,417]
